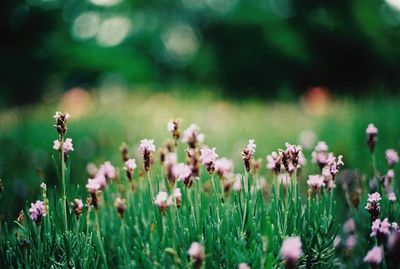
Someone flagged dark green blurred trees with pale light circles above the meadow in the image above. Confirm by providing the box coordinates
[0,0,400,107]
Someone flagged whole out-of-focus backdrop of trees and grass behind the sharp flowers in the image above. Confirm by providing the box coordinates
[0,0,400,221]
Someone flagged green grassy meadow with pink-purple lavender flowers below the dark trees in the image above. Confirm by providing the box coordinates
[0,89,400,268]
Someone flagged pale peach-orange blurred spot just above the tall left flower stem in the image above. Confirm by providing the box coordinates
[59,88,94,118]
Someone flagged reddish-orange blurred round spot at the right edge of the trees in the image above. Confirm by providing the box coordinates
[301,86,331,115]
